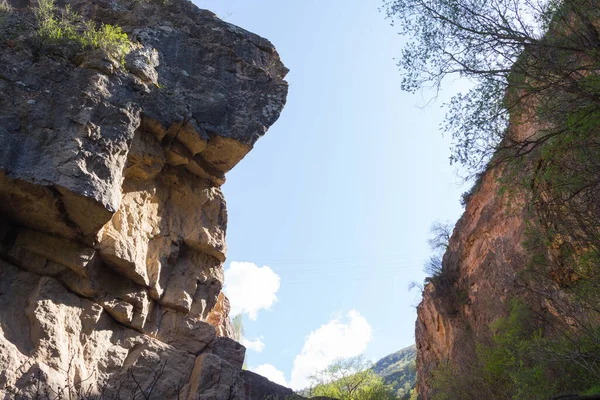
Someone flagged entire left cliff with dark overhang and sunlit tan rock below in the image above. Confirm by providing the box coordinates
[0,0,287,399]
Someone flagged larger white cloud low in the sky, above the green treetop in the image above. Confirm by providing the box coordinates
[289,310,372,390]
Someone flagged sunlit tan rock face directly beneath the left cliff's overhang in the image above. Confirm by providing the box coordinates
[97,168,227,294]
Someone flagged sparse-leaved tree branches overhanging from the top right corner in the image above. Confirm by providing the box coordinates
[384,0,600,173]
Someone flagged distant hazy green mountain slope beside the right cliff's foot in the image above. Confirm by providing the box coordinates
[373,345,417,399]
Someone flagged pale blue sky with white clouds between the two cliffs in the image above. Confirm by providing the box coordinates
[195,0,467,388]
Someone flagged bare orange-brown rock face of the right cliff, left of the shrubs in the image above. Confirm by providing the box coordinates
[415,164,526,399]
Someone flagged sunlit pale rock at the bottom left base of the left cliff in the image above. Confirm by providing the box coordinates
[0,261,195,398]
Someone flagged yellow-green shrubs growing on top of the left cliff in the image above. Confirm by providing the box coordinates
[34,0,133,64]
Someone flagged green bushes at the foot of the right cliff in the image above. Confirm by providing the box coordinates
[433,299,600,400]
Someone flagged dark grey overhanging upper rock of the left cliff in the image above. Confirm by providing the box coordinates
[0,0,287,244]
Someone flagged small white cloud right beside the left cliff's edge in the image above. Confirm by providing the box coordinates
[224,261,281,321]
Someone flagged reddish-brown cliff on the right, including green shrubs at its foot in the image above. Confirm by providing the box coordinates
[415,41,600,399]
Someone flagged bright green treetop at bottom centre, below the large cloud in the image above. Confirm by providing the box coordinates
[306,356,396,400]
